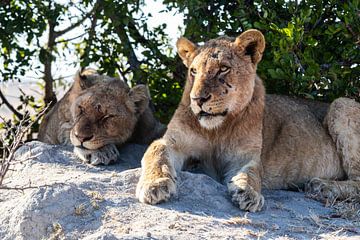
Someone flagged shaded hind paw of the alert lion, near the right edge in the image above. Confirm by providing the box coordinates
[305,178,340,202]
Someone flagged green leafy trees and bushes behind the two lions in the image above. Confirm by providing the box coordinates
[0,0,360,143]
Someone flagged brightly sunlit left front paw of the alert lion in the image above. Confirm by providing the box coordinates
[136,177,176,205]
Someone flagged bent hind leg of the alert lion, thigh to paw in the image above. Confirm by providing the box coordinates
[308,98,360,200]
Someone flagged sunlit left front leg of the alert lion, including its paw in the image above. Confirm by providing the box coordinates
[136,138,184,204]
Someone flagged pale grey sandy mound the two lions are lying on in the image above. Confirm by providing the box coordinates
[0,142,360,240]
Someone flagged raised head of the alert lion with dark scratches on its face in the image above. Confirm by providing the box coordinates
[176,30,265,129]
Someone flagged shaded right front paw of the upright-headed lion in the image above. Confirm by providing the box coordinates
[228,183,264,212]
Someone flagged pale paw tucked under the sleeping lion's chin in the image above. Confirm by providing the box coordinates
[74,144,119,165]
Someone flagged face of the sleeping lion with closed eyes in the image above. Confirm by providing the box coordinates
[70,81,149,150]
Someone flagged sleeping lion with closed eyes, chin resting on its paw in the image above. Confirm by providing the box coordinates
[38,69,165,165]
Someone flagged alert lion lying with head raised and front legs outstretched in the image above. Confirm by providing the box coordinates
[136,29,360,212]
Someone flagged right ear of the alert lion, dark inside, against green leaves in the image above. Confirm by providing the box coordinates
[234,29,265,64]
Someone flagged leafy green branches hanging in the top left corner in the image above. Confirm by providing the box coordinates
[0,0,46,81]
